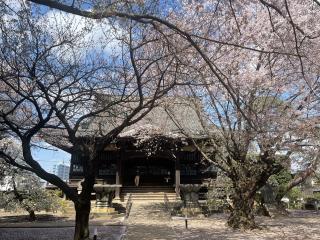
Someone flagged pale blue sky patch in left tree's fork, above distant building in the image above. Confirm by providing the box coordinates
[32,144,71,173]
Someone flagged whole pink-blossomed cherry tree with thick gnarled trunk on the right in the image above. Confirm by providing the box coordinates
[165,1,319,229]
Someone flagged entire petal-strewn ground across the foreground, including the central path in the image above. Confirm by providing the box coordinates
[0,207,320,240]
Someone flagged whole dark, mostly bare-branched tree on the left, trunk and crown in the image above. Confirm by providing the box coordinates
[0,1,181,240]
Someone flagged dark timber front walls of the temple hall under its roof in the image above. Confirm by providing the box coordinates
[70,142,207,198]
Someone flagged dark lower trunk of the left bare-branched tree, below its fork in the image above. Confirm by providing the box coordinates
[73,199,91,240]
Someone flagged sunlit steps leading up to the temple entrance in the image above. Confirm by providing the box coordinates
[120,186,180,202]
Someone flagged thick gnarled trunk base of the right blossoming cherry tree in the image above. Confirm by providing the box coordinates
[228,189,257,229]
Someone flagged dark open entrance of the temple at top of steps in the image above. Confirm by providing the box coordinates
[122,158,175,186]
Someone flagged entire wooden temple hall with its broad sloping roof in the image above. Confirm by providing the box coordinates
[70,99,215,201]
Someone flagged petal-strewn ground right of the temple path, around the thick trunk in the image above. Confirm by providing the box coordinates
[172,211,320,240]
